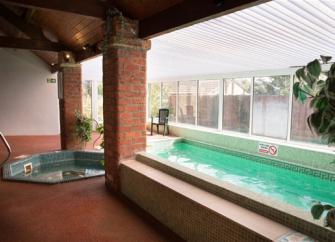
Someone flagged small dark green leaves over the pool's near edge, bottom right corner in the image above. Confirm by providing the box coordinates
[311,202,335,229]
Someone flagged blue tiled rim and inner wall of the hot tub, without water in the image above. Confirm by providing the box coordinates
[2,151,104,184]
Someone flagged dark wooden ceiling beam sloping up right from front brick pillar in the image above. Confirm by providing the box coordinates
[139,0,269,39]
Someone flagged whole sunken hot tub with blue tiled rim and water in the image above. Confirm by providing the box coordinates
[2,151,104,184]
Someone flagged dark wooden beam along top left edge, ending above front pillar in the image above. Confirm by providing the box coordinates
[0,0,115,19]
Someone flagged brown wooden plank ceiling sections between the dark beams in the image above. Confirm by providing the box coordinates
[0,0,182,69]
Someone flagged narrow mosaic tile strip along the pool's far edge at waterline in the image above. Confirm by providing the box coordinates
[184,139,335,181]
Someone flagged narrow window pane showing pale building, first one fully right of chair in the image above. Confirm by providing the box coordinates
[178,81,197,124]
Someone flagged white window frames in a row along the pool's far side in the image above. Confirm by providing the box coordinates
[147,68,332,152]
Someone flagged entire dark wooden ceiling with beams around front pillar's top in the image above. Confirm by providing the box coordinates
[0,0,266,72]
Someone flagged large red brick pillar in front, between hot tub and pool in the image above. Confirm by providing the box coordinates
[103,17,150,191]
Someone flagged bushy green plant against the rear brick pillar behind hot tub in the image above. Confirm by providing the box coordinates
[75,111,92,143]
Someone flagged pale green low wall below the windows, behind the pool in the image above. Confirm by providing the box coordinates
[170,126,335,173]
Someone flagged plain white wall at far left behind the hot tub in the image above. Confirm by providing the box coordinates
[0,48,60,135]
